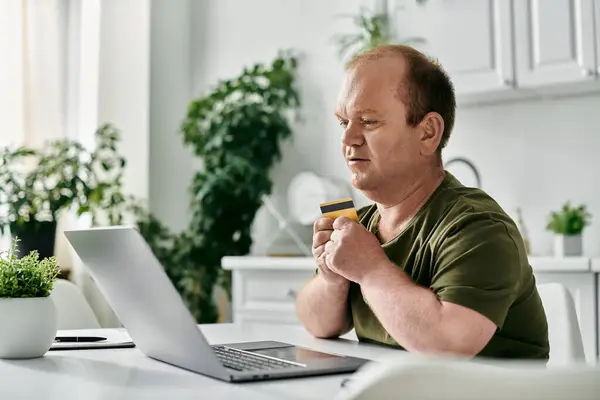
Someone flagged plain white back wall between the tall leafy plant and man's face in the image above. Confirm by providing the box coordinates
[194,0,374,194]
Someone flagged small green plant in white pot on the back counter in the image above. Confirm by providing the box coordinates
[546,202,591,257]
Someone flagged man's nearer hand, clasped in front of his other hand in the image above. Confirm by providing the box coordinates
[324,217,389,284]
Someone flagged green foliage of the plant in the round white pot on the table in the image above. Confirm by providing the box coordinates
[0,238,59,298]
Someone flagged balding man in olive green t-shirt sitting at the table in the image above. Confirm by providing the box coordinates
[296,46,549,361]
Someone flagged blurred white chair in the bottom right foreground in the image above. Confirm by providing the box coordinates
[336,357,600,400]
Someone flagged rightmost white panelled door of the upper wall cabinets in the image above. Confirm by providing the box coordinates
[513,0,596,88]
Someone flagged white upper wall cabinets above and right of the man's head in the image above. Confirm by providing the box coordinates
[381,0,600,105]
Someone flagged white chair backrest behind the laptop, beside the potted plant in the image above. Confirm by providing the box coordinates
[50,279,100,329]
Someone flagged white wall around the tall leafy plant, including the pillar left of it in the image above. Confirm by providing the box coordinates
[150,0,374,252]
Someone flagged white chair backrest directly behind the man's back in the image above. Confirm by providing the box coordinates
[538,283,585,365]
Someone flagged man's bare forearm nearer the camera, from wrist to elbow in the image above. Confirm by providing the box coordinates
[361,265,448,353]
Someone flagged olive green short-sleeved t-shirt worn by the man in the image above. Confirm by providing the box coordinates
[349,173,549,360]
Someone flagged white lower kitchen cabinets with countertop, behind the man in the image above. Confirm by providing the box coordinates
[222,256,600,364]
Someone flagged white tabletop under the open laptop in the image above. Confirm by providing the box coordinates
[0,324,409,400]
